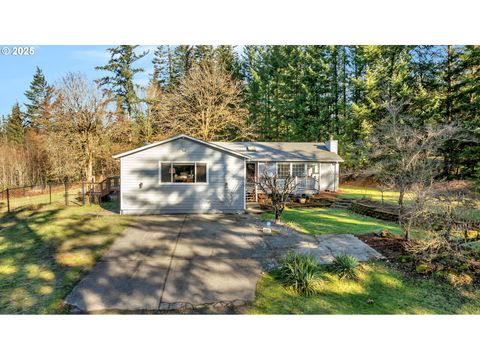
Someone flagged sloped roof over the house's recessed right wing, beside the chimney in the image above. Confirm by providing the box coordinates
[213,141,343,162]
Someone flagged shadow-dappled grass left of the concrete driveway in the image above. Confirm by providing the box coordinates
[0,204,131,314]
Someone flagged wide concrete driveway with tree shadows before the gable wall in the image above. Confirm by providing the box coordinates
[65,215,271,312]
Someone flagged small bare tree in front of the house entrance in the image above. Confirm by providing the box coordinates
[257,170,296,222]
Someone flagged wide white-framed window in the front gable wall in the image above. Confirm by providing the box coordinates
[160,162,207,184]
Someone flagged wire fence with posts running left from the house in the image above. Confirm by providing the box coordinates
[0,176,120,213]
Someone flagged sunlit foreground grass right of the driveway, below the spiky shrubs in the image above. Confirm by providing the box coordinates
[247,261,480,314]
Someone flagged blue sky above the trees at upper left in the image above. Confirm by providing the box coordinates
[0,45,155,115]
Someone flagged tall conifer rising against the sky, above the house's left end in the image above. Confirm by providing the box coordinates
[95,45,148,117]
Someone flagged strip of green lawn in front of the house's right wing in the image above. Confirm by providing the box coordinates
[263,208,401,235]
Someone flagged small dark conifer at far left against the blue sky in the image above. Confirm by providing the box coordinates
[24,66,53,128]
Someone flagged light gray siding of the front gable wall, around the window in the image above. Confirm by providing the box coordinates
[120,139,245,214]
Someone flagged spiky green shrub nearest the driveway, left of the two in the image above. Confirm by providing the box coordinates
[280,252,320,295]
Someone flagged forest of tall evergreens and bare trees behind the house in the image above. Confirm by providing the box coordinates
[0,45,480,188]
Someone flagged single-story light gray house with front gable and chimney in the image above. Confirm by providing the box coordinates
[114,135,343,214]
